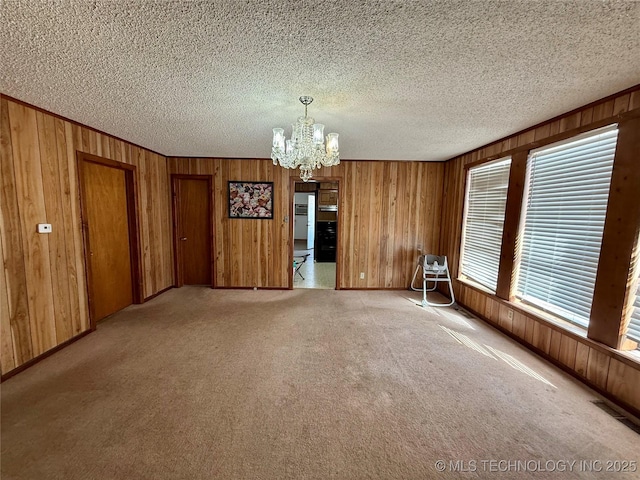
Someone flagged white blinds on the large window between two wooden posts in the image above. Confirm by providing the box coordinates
[517,125,618,327]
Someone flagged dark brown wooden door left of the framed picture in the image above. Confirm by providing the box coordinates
[173,176,213,287]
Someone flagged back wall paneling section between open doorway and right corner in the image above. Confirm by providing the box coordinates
[338,161,444,288]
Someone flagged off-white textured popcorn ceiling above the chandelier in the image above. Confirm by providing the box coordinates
[0,0,640,160]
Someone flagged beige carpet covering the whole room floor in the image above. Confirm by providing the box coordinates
[1,287,640,480]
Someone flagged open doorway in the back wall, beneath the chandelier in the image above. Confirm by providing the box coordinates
[292,179,339,289]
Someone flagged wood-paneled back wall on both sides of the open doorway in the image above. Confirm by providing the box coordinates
[169,158,444,288]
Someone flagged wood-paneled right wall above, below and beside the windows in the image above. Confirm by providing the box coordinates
[441,87,640,414]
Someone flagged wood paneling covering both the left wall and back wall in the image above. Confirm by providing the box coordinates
[0,96,444,374]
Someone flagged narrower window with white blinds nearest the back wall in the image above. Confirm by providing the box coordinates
[460,158,511,291]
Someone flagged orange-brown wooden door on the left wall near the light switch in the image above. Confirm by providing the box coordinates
[82,161,133,322]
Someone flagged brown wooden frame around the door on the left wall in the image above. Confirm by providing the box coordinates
[76,151,144,330]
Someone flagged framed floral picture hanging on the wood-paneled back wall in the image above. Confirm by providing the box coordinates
[229,181,273,220]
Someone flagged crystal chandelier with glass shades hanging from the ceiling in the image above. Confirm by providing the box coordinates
[271,96,340,182]
